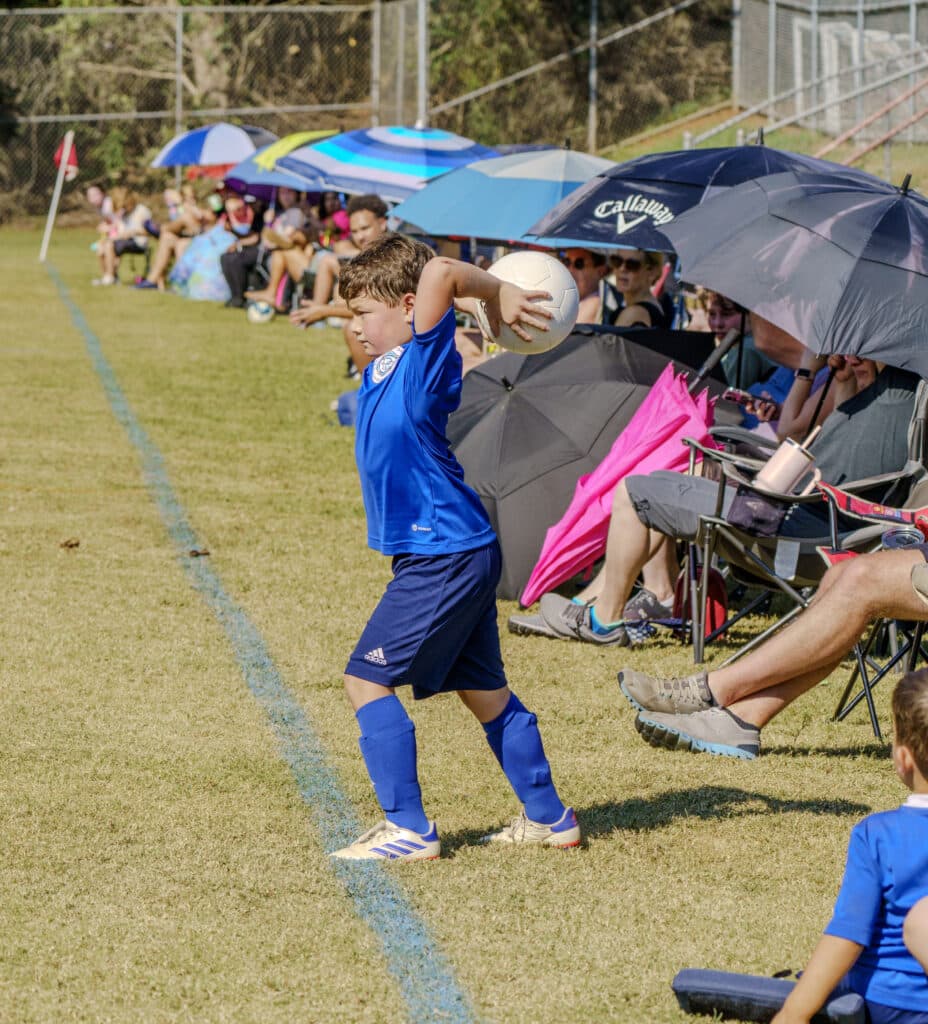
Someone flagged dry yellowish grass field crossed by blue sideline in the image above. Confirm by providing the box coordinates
[0,229,903,1024]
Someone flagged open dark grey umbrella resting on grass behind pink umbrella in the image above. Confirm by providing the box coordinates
[448,329,720,598]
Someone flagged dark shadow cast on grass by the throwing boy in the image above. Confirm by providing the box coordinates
[441,782,882,857]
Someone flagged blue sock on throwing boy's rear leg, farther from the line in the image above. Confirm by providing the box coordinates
[483,693,564,824]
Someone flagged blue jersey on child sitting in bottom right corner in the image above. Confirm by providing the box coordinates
[825,797,928,1012]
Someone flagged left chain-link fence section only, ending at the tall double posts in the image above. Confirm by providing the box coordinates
[0,4,377,217]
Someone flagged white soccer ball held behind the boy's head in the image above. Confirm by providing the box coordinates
[476,251,580,355]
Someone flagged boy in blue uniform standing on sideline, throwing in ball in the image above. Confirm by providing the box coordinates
[333,234,580,860]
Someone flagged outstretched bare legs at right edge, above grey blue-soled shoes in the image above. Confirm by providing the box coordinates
[709,551,928,726]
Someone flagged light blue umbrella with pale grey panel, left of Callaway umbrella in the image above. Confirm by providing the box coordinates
[391,148,616,242]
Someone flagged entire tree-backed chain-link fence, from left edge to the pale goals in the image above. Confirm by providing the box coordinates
[0,0,729,218]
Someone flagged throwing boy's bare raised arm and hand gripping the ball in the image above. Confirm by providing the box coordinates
[416,256,551,341]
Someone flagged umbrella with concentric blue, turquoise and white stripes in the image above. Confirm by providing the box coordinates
[277,127,497,201]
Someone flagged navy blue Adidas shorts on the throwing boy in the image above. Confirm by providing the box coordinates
[345,541,507,700]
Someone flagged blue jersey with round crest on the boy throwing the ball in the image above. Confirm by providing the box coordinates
[354,308,495,555]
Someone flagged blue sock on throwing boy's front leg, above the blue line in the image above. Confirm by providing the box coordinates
[355,693,432,836]
